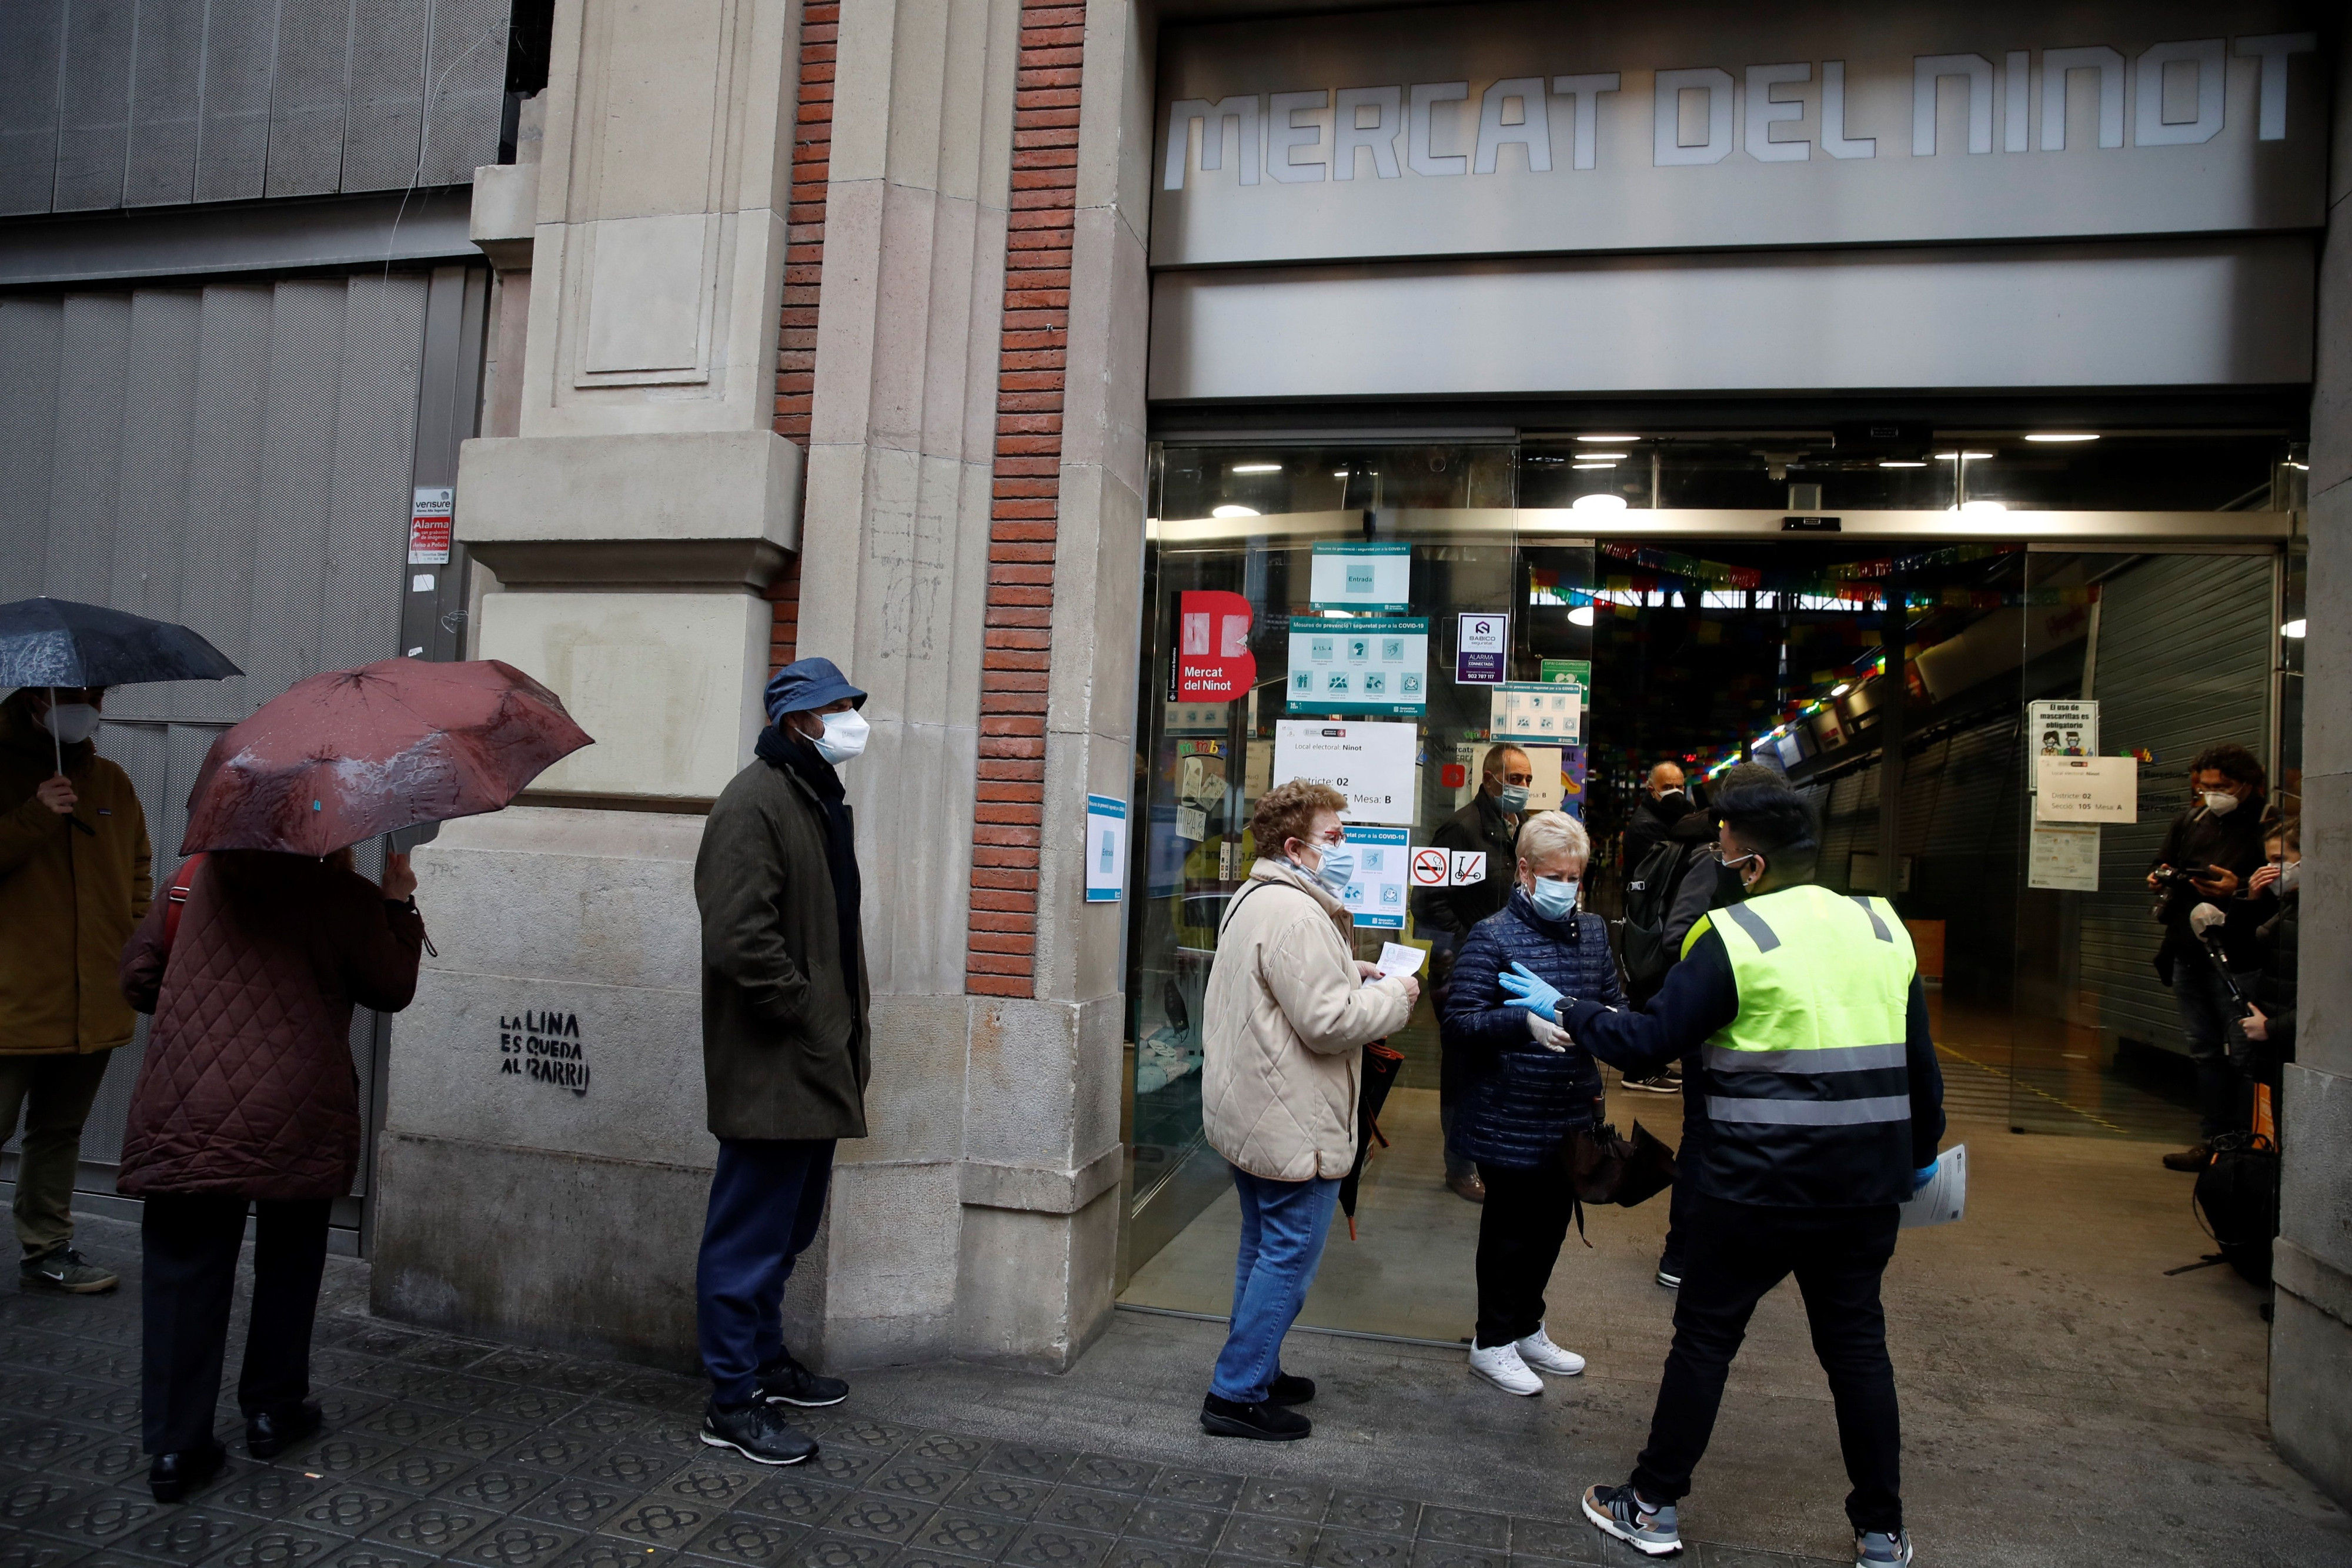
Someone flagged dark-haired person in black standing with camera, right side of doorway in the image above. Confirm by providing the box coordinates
[2147,743,2267,1171]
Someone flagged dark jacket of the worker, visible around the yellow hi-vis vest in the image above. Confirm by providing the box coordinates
[1559,902,1943,1208]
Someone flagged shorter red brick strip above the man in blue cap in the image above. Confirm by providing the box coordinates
[767,0,842,670]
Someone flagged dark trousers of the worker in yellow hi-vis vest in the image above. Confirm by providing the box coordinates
[1637,1194,1903,1530]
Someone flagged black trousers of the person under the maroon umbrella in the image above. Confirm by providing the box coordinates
[139,1192,329,1453]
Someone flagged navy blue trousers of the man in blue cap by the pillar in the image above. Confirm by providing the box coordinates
[694,1138,833,1408]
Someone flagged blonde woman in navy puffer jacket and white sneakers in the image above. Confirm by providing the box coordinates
[1444,811,1621,1394]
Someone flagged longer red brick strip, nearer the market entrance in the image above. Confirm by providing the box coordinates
[964,0,1087,997]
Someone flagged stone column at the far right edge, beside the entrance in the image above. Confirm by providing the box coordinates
[2270,27,2352,1507]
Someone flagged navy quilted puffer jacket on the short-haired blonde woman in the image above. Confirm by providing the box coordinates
[1444,888,1621,1171]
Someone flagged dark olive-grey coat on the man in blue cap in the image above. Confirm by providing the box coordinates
[694,760,873,1138]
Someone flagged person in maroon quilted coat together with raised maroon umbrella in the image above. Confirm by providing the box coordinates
[115,661,588,1502]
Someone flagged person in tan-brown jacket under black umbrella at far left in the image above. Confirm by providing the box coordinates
[0,687,153,1295]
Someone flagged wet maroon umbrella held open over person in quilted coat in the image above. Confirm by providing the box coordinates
[179,658,593,855]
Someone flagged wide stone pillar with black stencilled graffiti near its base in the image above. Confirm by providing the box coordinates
[374,0,802,1366]
